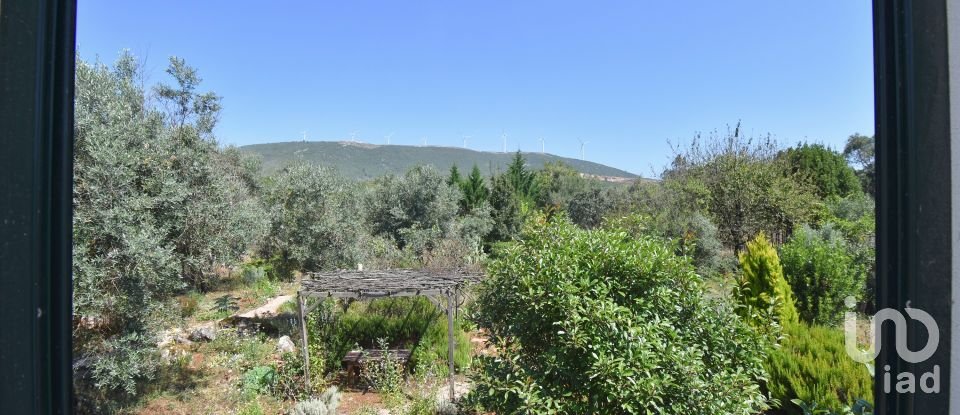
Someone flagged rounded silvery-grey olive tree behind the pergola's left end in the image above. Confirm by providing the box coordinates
[262,162,363,277]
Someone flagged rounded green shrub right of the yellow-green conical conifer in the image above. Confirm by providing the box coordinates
[781,227,866,326]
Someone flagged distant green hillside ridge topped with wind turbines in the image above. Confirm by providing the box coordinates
[240,141,637,181]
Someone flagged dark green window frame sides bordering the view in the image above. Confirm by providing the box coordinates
[0,0,960,414]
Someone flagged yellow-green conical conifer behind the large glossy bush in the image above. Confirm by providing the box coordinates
[738,232,798,325]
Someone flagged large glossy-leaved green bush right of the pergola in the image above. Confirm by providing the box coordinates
[469,216,766,414]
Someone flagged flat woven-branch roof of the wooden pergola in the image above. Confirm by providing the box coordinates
[300,270,481,298]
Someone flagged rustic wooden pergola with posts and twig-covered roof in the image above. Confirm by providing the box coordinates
[297,270,481,401]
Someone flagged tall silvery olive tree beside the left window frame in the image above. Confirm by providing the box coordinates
[73,53,265,412]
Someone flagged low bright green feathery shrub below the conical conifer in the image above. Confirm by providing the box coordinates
[766,323,873,414]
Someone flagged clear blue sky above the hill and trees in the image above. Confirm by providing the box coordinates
[78,0,873,175]
